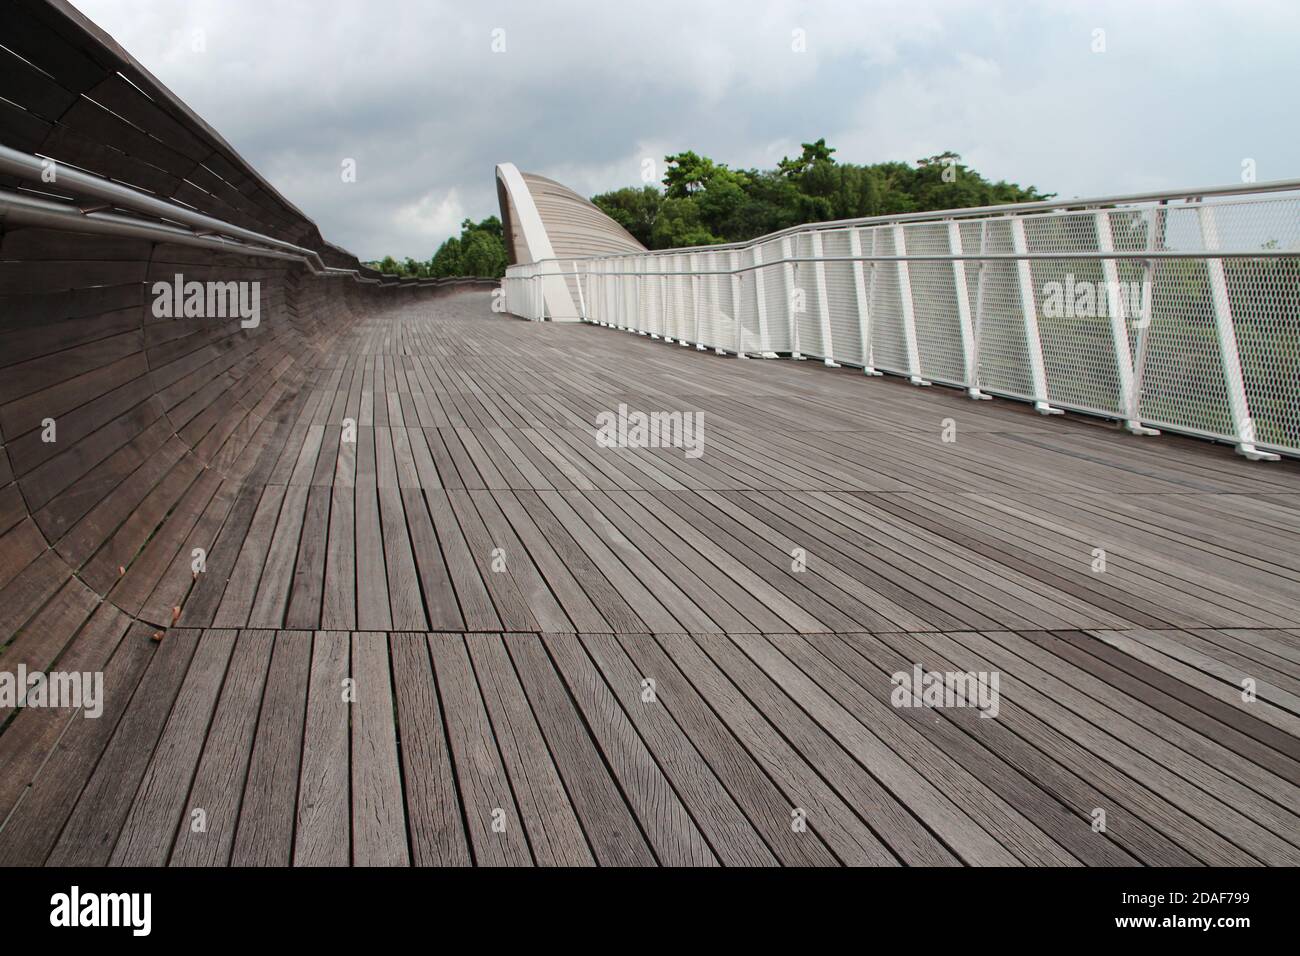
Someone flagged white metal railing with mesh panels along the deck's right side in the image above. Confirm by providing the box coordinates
[503,181,1300,458]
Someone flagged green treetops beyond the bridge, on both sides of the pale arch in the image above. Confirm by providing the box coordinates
[369,138,1056,277]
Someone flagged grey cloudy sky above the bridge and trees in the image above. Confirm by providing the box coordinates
[73,0,1300,259]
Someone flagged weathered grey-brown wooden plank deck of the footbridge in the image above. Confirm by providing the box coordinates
[0,293,1300,865]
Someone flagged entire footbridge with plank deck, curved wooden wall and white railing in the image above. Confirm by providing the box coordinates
[0,0,1300,866]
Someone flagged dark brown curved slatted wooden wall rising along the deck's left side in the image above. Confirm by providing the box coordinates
[0,0,494,667]
